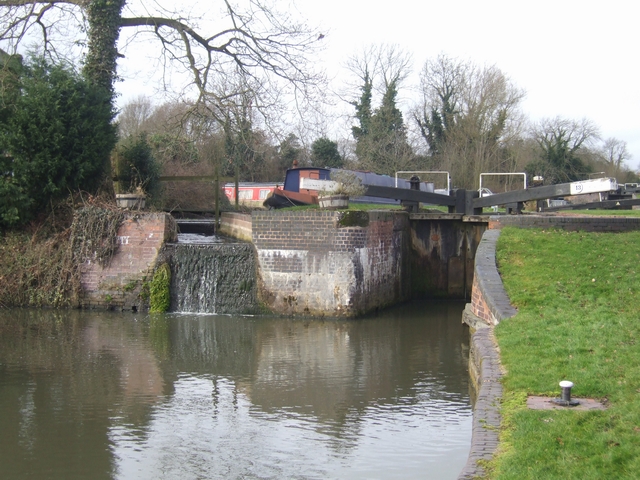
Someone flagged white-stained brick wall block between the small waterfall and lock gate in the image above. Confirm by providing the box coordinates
[252,210,410,316]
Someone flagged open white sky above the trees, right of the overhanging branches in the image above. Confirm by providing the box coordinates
[120,0,640,168]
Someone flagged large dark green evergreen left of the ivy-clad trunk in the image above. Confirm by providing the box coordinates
[0,59,116,227]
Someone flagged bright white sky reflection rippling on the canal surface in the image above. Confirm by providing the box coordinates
[110,374,471,479]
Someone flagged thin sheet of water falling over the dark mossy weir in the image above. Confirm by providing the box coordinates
[166,241,258,314]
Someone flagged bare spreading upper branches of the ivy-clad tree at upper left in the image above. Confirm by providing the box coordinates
[0,0,323,115]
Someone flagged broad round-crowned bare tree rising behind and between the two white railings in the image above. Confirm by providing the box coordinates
[413,54,524,188]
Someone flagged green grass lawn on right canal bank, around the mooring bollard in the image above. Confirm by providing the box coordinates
[488,228,640,480]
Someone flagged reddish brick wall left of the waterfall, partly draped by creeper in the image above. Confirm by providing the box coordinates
[81,212,177,310]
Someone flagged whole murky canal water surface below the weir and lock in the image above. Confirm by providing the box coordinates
[0,302,472,480]
